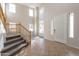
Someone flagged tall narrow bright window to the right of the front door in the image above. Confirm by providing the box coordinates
[69,13,74,38]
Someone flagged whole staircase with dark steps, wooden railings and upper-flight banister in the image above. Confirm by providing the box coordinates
[0,4,31,56]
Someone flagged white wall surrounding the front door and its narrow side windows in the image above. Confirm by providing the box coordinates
[40,4,79,48]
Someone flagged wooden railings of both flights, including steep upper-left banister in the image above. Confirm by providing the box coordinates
[0,4,31,42]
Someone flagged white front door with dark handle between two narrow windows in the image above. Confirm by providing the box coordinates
[53,14,67,43]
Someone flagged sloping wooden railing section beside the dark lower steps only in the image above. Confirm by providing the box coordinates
[17,24,31,43]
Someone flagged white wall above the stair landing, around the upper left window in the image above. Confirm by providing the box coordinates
[6,3,33,28]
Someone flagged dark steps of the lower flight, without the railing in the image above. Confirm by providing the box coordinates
[1,35,28,56]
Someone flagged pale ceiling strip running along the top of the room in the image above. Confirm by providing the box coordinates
[20,3,79,8]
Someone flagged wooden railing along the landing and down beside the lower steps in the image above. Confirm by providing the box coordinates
[6,23,31,43]
